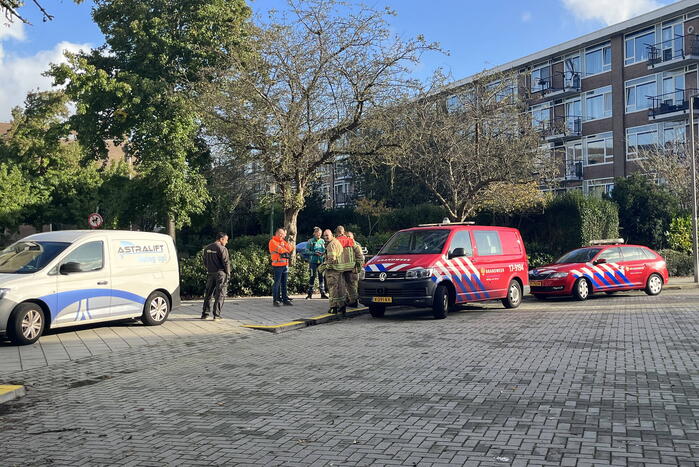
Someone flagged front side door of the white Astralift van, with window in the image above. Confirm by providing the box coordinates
[53,238,111,324]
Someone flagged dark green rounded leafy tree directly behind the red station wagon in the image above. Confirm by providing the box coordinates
[611,174,680,249]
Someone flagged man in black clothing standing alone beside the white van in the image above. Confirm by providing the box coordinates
[201,232,231,320]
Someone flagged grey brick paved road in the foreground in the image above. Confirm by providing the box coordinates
[0,291,699,466]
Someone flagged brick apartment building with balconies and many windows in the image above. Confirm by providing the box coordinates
[447,0,699,195]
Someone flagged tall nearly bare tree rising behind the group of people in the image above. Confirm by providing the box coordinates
[201,0,437,241]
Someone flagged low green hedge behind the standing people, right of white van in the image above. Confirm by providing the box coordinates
[180,246,309,297]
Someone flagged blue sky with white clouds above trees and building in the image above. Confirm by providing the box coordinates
[0,0,675,122]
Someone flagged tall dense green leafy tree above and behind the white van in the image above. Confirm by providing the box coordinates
[49,0,250,237]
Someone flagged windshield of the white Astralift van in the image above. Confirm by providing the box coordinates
[0,241,70,274]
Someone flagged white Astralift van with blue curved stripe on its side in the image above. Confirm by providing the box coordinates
[0,230,180,345]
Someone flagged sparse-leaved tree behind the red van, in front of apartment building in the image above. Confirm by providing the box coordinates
[365,73,558,221]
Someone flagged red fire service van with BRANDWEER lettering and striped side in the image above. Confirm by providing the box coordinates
[359,223,528,319]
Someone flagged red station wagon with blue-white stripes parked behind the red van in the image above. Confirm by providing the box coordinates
[529,239,669,300]
